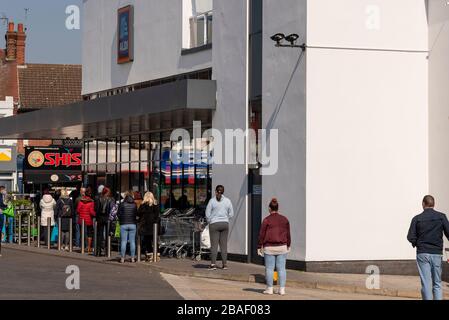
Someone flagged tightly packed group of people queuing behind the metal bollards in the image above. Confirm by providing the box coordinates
[31,186,161,263]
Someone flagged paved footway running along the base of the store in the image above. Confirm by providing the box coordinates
[3,244,449,300]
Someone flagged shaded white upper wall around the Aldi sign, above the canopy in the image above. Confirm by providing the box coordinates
[82,0,212,94]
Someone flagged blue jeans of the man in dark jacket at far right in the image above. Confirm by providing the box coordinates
[416,253,443,300]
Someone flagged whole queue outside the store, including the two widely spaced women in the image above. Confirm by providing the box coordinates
[0,185,298,295]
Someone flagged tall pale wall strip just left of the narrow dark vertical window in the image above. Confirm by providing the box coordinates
[212,0,248,254]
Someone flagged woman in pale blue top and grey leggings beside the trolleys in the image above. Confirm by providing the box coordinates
[206,185,234,270]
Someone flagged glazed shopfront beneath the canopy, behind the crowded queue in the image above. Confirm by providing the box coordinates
[83,131,212,211]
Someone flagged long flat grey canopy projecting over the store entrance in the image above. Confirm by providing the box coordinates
[0,79,216,140]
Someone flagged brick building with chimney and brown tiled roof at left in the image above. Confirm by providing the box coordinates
[0,22,81,190]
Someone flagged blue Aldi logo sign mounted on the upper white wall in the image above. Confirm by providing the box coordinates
[117,5,134,63]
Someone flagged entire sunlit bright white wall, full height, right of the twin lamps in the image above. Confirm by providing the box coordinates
[306,0,429,261]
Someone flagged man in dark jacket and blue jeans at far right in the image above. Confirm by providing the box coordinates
[407,195,449,300]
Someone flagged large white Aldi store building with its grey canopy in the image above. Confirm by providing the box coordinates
[0,0,449,274]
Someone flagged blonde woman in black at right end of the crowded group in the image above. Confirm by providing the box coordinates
[137,192,161,257]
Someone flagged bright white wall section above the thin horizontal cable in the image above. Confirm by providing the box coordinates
[307,0,427,51]
